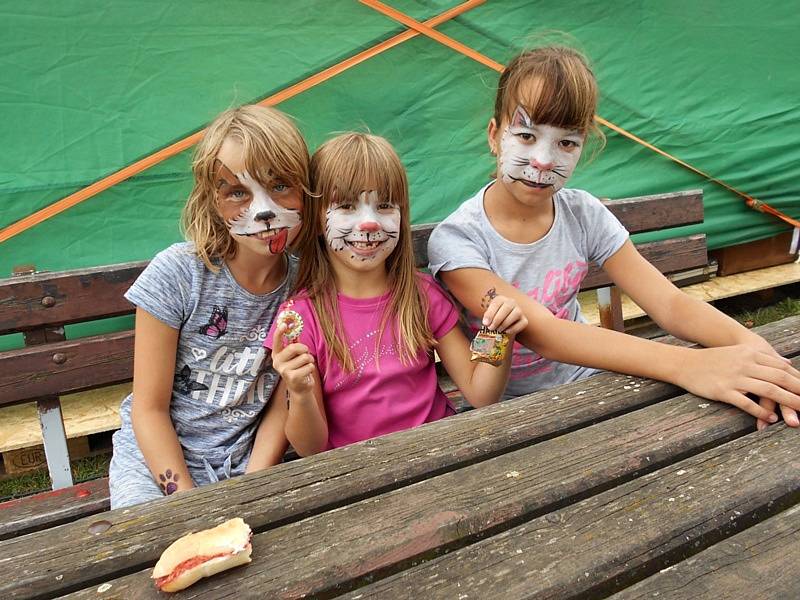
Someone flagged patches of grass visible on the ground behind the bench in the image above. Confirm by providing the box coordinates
[0,285,800,501]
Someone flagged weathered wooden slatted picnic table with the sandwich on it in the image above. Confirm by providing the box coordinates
[0,317,800,600]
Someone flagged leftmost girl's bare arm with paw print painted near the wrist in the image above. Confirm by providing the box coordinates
[131,308,194,495]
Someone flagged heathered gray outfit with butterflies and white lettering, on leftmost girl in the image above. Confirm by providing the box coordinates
[110,242,297,505]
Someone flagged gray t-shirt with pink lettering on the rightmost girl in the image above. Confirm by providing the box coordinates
[428,183,628,398]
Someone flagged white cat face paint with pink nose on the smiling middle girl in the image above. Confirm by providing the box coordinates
[325,190,400,263]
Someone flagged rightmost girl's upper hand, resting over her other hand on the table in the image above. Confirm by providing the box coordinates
[678,344,800,428]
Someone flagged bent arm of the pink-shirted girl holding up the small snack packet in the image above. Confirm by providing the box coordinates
[436,296,528,408]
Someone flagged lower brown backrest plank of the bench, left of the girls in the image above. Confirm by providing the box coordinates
[0,331,133,406]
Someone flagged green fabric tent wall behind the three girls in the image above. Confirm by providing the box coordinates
[0,0,800,276]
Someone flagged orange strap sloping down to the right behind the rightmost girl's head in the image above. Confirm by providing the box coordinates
[360,0,800,227]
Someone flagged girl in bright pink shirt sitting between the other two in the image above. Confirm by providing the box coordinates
[265,133,527,456]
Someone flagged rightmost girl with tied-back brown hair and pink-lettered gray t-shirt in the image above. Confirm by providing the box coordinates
[428,47,800,429]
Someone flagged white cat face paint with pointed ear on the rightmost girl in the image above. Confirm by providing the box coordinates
[499,106,586,194]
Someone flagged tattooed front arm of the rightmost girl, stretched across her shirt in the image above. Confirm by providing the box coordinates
[441,268,800,423]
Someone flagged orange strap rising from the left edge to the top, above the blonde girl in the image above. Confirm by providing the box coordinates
[0,0,486,243]
